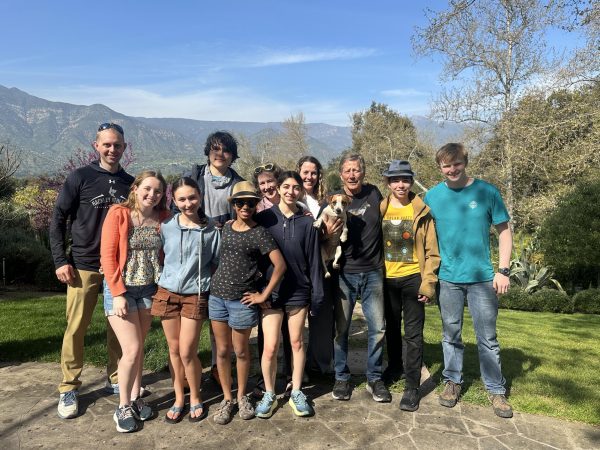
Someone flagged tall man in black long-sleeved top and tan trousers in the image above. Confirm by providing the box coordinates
[50,123,133,419]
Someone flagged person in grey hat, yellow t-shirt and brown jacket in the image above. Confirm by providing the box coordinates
[380,160,439,411]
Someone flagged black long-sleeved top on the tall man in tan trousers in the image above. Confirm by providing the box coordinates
[50,161,134,272]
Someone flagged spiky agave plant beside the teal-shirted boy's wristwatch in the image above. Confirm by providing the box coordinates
[510,239,565,294]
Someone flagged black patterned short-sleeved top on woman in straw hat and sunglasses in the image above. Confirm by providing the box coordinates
[210,223,278,300]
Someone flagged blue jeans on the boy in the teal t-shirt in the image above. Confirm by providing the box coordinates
[438,280,506,394]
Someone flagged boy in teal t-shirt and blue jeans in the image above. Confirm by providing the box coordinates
[425,143,512,418]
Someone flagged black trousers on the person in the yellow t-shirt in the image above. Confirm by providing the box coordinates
[384,273,425,388]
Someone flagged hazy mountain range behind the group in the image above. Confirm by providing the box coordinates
[0,85,462,176]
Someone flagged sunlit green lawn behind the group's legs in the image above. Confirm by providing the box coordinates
[0,294,600,424]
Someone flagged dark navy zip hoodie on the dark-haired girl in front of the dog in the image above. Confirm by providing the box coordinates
[256,205,323,315]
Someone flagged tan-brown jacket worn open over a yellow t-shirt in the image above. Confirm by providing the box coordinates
[379,192,440,298]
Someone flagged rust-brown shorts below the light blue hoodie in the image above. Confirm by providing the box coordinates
[152,286,208,320]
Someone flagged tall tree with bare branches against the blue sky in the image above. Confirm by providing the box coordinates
[413,0,561,220]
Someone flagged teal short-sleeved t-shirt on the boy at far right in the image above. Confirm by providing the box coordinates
[425,179,510,283]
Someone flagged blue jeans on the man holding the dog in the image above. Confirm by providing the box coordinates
[333,269,385,382]
